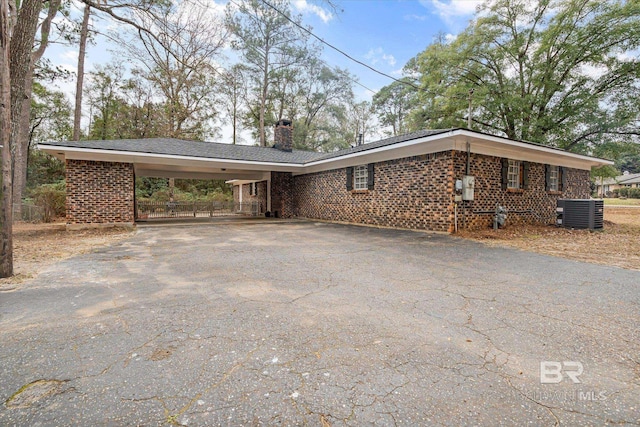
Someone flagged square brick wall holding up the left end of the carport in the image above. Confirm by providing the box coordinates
[66,160,135,224]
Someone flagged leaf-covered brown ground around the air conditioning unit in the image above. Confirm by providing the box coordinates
[458,207,640,270]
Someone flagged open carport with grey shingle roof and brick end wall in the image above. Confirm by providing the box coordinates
[39,123,319,228]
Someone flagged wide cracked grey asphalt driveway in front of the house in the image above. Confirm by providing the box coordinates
[0,222,640,427]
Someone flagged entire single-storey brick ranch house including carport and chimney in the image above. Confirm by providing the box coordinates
[40,121,612,232]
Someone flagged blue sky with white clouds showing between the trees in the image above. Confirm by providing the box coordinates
[46,0,481,138]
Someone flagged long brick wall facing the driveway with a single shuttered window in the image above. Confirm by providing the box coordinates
[294,152,453,231]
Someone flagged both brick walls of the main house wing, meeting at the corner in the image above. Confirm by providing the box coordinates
[290,151,589,232]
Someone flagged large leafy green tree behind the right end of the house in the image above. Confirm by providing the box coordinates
[410,0,640,152]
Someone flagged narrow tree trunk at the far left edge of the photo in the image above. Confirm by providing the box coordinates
[0,0,13,277]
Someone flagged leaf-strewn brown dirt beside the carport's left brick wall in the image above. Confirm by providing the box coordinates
[0,223,134,291]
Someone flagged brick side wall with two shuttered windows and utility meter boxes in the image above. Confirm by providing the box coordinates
[454,151,590,229]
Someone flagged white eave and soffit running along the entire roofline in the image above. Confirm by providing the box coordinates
[39,129,613,182]
